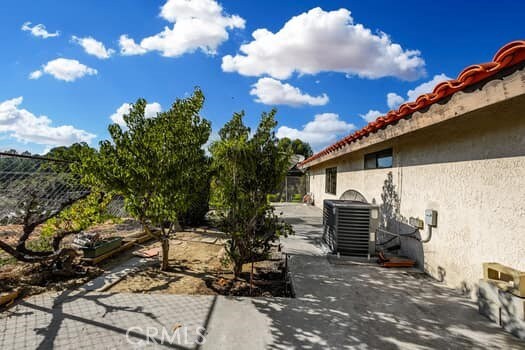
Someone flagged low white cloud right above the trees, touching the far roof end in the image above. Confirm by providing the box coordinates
[276,113,355,150]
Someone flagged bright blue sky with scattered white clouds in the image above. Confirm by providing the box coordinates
[0,0,525,153]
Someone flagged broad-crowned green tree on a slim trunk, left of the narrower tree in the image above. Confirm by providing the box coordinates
[83,89,211,270]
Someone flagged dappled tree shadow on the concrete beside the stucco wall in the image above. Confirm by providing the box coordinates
[253,257,523,349]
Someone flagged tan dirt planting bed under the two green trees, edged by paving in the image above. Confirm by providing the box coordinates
[109,232,286,296]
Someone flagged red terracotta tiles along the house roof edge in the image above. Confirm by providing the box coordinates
[299,40,525,165]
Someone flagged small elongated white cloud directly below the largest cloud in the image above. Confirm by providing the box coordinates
[250,78,329,106]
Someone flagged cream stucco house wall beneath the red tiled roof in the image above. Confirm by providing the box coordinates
[309,94,525,292]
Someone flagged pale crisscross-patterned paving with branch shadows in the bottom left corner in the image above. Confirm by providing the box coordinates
[0,292,214,350]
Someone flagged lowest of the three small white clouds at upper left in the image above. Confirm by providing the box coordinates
[29,58,98,82]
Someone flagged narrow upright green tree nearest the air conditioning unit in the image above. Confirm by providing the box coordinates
[210,110,291,278]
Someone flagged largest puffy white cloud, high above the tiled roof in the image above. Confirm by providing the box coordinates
[222,7,425,80]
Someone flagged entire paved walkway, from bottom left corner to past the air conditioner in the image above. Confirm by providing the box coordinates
[0,205,525,350]
